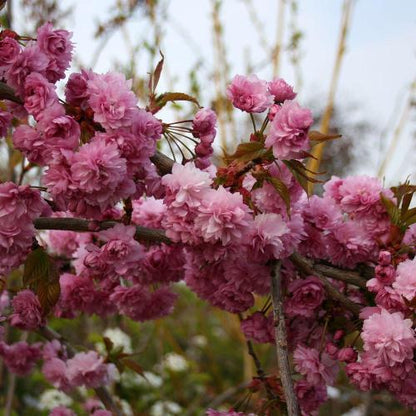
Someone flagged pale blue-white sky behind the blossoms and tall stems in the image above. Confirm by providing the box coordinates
[14,0,416,182]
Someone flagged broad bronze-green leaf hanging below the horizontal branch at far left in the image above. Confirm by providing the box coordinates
[23,247,61,315]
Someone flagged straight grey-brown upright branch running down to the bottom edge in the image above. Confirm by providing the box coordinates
[271,261,300,416]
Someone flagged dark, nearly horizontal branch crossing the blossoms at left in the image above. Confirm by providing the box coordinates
[33,217,171,244]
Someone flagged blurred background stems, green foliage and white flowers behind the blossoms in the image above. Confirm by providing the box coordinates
[0,0,414,416]
